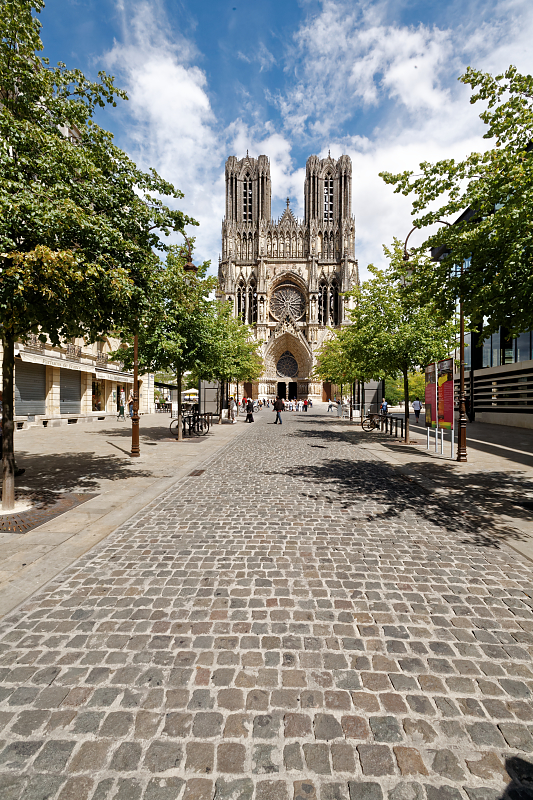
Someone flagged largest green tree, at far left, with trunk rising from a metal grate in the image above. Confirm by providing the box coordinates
[0,0,192,509]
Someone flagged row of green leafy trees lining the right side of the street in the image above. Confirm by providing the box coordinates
[317,66,533,440]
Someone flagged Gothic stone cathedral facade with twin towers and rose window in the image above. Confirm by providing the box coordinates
[219,154,358,399]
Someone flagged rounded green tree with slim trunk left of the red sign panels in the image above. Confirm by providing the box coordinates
[343,240,457,442]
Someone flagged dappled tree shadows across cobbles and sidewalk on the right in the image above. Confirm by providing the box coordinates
[287,421,533,548]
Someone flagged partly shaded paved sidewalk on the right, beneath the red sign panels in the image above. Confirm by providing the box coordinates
[343,415,533,560]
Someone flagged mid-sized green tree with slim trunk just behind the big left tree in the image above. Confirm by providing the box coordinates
[114,245,217,439]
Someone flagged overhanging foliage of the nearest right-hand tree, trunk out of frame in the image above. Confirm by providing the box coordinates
[381,66,533,334]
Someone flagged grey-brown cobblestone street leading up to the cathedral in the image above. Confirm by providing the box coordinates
[0,412,533,800]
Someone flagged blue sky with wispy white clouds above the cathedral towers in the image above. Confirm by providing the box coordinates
[40,0,533,277]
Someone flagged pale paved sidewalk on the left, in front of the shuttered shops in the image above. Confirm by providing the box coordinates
[0,414,244,617]
